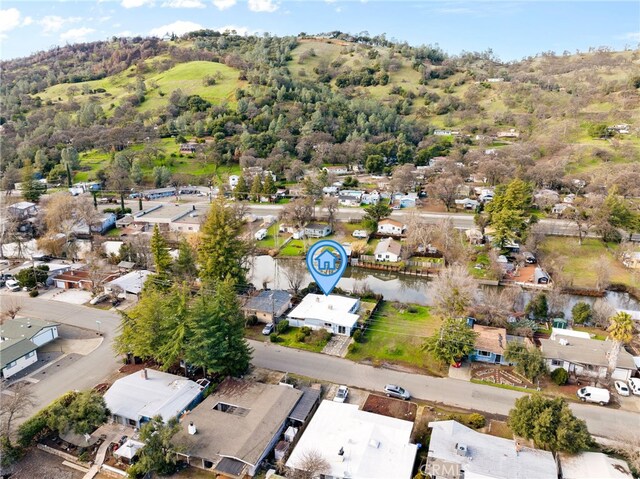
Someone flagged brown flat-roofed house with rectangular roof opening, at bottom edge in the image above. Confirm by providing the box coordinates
[176,378,303,479]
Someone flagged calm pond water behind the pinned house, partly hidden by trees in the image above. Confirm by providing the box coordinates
[250,255,640,316]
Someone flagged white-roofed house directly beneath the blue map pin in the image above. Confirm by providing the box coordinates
[287,294,360,336]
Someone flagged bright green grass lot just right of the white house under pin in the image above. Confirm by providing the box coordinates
[347,301,447,375]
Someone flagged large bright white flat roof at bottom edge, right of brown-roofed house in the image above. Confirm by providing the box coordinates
[287,400,417,479]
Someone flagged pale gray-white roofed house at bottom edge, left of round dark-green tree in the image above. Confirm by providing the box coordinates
[427,421,558,479]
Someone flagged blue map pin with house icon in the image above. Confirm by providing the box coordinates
[307,240,347,296]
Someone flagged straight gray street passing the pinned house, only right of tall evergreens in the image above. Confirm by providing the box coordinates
[250,341,640,439]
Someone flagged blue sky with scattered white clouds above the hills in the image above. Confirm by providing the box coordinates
[0,0,640,60]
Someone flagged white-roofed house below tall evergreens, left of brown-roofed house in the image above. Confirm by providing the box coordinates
[104,369,209,427]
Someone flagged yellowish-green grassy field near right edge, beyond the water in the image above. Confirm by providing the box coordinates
[540,236,638,288]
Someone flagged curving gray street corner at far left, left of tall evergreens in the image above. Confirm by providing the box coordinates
[0,293,122,423]
